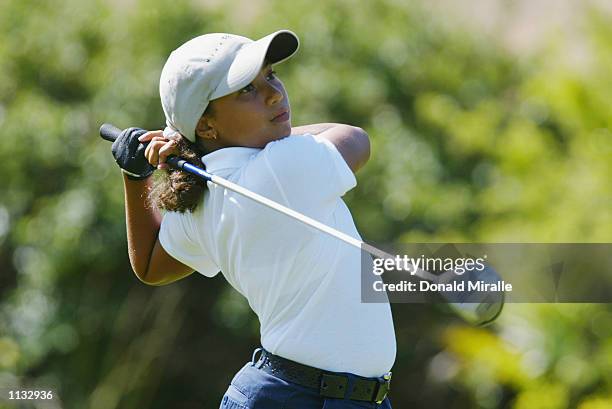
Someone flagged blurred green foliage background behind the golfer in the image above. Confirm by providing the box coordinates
[0,0,612,409]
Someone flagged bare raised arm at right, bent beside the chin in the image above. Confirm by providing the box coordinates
[291,123,370,173]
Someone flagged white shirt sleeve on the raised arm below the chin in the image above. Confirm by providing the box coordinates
[261,134,357,212]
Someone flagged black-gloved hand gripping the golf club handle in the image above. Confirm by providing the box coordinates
[111,128,155,180]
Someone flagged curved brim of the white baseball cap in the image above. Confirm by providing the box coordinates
[210,30,300,100]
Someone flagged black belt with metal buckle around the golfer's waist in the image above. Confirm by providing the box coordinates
[252,348,391,404]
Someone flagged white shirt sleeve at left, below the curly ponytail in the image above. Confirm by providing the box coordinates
[158,212,220,277]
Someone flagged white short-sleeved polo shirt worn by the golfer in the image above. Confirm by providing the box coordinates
[159,134,396,377]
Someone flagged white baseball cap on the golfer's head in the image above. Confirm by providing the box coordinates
[159,30,299,142]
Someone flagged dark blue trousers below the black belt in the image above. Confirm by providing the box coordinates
[219,350,391,409]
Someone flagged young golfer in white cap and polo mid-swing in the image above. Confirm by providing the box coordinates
[113,30,396,409]
